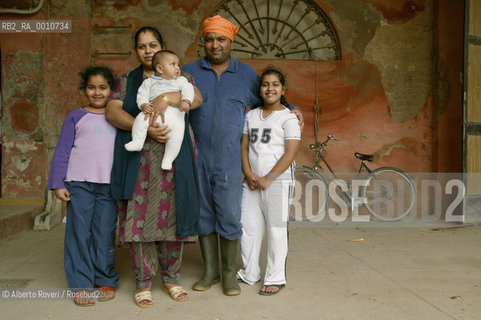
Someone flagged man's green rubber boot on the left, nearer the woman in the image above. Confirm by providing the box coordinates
[192,232,220,291]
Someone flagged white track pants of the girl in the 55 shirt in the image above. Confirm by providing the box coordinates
[237,174,292,285]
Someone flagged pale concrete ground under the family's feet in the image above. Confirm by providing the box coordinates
[0,222,481,320]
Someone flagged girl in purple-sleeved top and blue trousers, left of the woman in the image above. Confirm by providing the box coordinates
[48,67,119,306]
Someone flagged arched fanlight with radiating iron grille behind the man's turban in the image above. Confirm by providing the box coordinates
[198,0,341,60]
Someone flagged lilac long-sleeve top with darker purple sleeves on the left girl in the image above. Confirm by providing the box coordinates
[47,108,116,190]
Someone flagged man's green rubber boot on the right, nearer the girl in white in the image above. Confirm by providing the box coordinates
[219,237,240,296]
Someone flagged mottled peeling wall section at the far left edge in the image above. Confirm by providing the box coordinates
[1,38,45,198]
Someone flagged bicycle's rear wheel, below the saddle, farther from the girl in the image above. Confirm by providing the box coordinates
[362,167,416,221]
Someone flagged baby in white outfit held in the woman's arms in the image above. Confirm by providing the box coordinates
[125,50,194,170]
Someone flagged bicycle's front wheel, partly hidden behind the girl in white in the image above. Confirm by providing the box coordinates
[289,167,330,221]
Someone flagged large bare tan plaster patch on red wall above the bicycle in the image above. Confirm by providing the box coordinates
[364,8,433,122]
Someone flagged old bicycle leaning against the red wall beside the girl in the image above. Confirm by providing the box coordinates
[289,135,416,221]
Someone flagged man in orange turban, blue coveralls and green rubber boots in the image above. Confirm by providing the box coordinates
[183,16,261,296]
